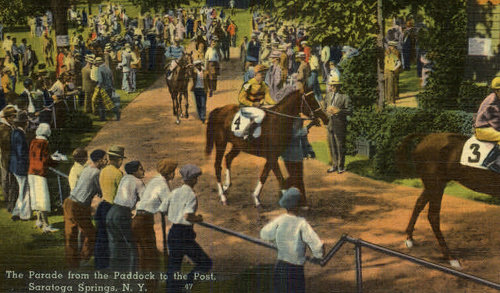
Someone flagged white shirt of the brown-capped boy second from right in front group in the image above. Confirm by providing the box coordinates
[136,175,171,214]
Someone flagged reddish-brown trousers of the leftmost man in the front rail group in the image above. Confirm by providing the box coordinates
[63,198,96,267]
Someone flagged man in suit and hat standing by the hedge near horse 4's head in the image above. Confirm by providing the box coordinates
[323,78,352,174]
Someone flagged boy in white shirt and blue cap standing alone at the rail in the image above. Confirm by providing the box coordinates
[260,187,324,292]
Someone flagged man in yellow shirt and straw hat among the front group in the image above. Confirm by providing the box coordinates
[94,146,125,269]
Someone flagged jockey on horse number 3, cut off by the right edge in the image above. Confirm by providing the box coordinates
[474,76,500,172]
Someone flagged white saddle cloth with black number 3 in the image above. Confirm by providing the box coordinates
[460,136,500,173]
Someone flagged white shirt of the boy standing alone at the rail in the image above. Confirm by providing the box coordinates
[260,214,323,265]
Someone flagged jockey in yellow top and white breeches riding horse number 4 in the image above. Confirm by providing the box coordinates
[238,64,276,140]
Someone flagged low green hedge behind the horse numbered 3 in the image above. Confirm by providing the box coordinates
[347,107,473,176]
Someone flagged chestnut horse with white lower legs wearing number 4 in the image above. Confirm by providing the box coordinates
[205,90,328,207]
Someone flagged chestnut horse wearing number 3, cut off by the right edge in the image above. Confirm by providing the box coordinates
[396,133,500,267]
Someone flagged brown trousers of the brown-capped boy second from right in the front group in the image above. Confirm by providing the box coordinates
[132,213,160,292]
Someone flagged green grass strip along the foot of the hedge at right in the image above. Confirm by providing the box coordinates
[312,141,500,205]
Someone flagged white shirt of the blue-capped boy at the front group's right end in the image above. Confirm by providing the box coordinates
[160,184,198,225]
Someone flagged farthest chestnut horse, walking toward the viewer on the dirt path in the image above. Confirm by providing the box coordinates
[165,52,193,124]
